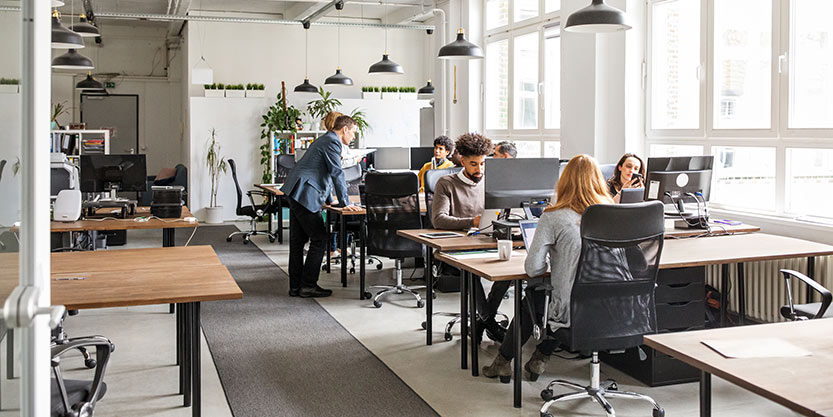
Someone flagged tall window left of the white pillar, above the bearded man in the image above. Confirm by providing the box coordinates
[482,0,561,157]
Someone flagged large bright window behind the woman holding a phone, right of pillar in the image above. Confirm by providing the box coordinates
[646,0,833,218]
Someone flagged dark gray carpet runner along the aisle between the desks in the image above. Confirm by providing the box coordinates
[177,226,437,417]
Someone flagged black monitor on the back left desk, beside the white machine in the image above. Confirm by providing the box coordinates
[81,154,147,193]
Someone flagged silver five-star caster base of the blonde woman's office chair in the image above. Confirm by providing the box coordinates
[541,352,665,417]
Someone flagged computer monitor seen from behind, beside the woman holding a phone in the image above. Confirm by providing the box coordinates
[645,155,714,204]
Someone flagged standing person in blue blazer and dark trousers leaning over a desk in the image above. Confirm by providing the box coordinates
[281,116,361,298]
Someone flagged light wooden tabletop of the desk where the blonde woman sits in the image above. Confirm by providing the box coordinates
[432,231,833,281]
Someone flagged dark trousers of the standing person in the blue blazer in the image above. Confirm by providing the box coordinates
[287,198,327,289]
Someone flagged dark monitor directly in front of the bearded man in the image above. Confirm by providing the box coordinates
[484,158,558,209]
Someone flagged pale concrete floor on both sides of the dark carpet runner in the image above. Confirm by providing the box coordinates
[0,223,796,417]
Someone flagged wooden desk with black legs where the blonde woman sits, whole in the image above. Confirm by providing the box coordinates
[436,233,833,407]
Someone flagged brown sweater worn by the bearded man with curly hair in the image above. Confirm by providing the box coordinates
[431,172,486,230]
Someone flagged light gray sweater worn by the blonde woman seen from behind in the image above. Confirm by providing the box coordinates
[524,208,581,331]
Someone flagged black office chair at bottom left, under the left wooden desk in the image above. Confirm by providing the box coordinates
[50,319,115,417]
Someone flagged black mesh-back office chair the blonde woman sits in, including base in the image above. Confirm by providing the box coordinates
[533,201,665,417]
